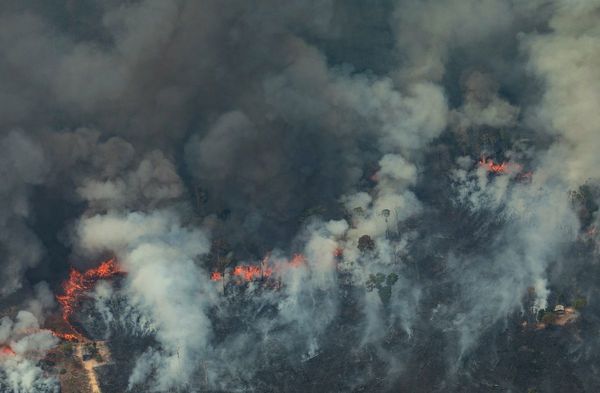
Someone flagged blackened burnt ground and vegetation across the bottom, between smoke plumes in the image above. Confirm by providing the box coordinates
[79,179,598,393]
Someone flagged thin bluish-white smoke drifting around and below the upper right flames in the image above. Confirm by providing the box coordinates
[449,162,579,354]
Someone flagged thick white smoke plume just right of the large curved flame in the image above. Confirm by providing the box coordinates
[77,211,215,390]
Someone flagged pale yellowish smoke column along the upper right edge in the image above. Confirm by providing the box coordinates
[523,1,600,187]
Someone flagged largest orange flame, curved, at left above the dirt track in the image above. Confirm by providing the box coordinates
[54,258,123,341]
